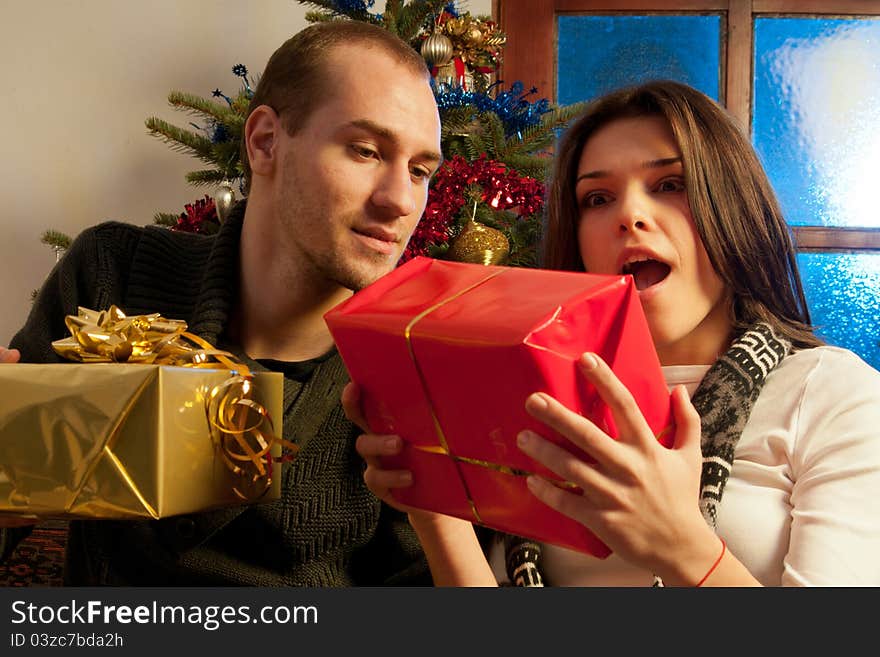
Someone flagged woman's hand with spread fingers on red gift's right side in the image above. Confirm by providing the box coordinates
[518,354,719,584]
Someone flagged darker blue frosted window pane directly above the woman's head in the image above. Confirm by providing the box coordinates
[556,14,721,105]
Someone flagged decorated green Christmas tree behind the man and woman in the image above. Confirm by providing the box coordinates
[44,0,582,267]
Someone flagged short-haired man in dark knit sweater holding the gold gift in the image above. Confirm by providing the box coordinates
[0,21,441,586]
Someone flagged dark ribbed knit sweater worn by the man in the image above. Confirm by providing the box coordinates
[0,203,431,586]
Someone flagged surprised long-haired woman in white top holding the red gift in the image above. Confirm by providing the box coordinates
[344,81,880,586]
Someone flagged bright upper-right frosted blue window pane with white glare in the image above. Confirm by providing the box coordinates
[752,18,880,226]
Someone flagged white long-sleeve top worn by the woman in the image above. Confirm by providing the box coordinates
[491,346,880,586]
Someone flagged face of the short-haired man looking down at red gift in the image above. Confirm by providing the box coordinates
[275,44,440,291]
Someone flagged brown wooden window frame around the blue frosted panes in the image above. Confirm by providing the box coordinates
[492,0,880,252]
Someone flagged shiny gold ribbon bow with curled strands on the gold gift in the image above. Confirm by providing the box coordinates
[52,305,299,501]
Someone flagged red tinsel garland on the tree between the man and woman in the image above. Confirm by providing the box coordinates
[401,153,544,262]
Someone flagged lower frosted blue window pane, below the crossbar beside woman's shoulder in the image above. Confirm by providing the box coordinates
[798,253,880,370]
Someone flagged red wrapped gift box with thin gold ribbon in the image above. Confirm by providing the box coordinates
[324,257,673,557]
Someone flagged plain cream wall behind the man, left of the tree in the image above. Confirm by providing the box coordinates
[0,0,491,345]
